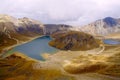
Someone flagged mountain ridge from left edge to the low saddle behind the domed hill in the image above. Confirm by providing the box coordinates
[0,15,72,36]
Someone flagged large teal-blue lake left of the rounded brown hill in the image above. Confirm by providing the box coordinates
[14,36,58,60]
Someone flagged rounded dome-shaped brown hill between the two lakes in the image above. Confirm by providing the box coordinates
[49,31,99,50]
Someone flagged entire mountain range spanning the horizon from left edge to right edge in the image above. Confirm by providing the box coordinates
[0,14,120,36]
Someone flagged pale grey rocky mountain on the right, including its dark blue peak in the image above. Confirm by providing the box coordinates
[78,17,120,35]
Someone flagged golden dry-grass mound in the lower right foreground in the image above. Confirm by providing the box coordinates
[64,46,120,77]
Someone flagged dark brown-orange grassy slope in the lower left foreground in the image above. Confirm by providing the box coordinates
[0,55,74,80]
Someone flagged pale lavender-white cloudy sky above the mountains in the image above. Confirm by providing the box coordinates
[0,0,120,26]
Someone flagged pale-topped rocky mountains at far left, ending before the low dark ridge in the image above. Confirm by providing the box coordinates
[0,15,43,35]
